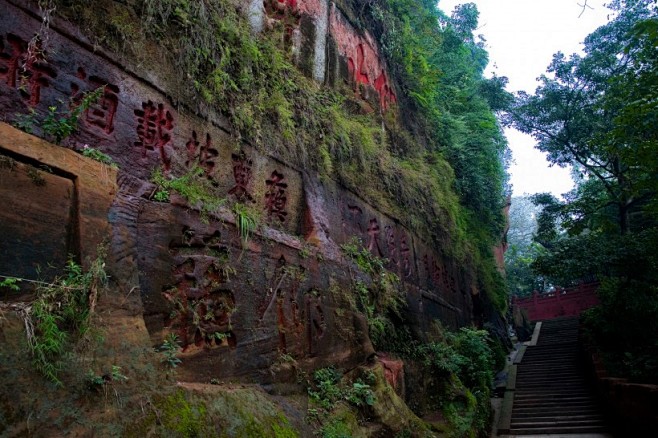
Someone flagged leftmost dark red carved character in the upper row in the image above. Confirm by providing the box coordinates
[0,34,57,106]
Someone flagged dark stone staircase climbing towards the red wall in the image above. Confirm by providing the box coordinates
[506,318,606,435]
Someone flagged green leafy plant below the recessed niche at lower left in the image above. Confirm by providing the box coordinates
[26,247,107,386]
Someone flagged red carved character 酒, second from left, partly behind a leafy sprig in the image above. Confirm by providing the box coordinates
[71,67,119,134]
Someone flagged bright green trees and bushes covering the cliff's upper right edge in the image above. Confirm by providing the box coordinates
[366,0,512,309]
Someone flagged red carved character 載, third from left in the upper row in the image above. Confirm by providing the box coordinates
[135,100,174,170]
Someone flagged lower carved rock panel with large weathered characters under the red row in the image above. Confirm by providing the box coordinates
[137,201,362,376]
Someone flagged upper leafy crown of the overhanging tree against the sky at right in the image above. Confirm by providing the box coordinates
[508,1,658,234]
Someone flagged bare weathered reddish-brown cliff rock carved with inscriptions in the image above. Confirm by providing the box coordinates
[0,0,502,435]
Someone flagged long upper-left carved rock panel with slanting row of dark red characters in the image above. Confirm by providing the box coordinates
[0,0,303,233]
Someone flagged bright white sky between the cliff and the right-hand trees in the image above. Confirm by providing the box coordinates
[439,0,610,196]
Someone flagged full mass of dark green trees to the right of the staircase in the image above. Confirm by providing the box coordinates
[506,0,658,381]
